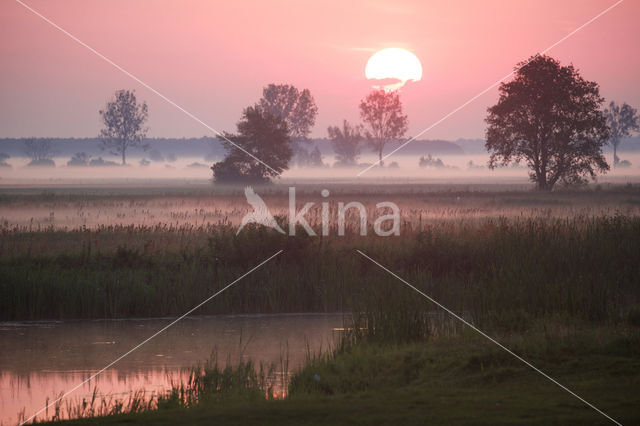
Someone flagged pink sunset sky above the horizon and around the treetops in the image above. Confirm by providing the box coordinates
[0,0,640,139]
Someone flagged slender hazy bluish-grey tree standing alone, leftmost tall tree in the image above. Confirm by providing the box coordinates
[100,90,149,165]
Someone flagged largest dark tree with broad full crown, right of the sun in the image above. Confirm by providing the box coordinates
[485,55,609,190]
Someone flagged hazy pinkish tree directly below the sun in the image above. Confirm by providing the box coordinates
[360,90,409,166]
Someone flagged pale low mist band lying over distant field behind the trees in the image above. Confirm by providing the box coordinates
[0,140,640,186]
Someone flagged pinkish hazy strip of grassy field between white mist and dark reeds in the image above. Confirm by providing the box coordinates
[0,182,640,232]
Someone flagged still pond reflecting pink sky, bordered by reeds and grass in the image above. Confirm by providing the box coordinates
[0,314,343,425]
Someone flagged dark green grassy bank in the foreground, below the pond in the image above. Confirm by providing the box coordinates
[42,328,640,425]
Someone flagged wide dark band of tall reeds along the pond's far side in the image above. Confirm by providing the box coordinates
[0,211,640,330]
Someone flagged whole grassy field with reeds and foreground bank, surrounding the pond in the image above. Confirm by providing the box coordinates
[5,185,640,424]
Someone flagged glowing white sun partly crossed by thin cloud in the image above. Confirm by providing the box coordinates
[364,47,422,91]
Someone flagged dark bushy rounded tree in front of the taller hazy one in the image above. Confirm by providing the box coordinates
[211,105,293,183]
